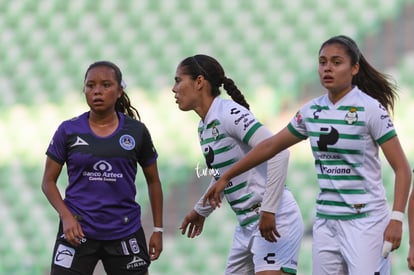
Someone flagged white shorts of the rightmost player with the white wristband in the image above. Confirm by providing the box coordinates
[312,211,391,275]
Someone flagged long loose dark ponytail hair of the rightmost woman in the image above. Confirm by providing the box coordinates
[319,35,397,112]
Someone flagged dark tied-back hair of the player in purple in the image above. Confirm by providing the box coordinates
[84,61,141,120]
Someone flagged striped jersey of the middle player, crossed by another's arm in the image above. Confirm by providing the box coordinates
[198,97,267,226]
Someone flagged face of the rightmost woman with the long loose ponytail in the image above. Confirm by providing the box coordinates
[318,43,359,96]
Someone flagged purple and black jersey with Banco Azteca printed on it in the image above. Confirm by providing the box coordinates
[46,112,158,240]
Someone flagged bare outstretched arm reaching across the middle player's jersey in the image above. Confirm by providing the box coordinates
[203,127,301,207]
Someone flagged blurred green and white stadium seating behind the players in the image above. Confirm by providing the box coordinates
[0,0,414,275]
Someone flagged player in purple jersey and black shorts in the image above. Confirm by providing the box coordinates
[42,61,163,275]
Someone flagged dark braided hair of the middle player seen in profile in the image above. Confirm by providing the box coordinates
[180,54,250,109]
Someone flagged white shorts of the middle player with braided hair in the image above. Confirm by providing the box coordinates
[225,192,303,275]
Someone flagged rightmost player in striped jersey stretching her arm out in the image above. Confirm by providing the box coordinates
[204,35,411,275]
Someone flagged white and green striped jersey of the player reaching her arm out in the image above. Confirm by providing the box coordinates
[288,87,396,219]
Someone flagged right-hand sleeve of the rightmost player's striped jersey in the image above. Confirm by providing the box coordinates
[366,103,397,145]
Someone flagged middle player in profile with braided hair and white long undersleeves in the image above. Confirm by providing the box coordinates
[172,55,303,275]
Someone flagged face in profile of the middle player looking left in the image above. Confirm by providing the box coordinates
[172,66,201,111]
